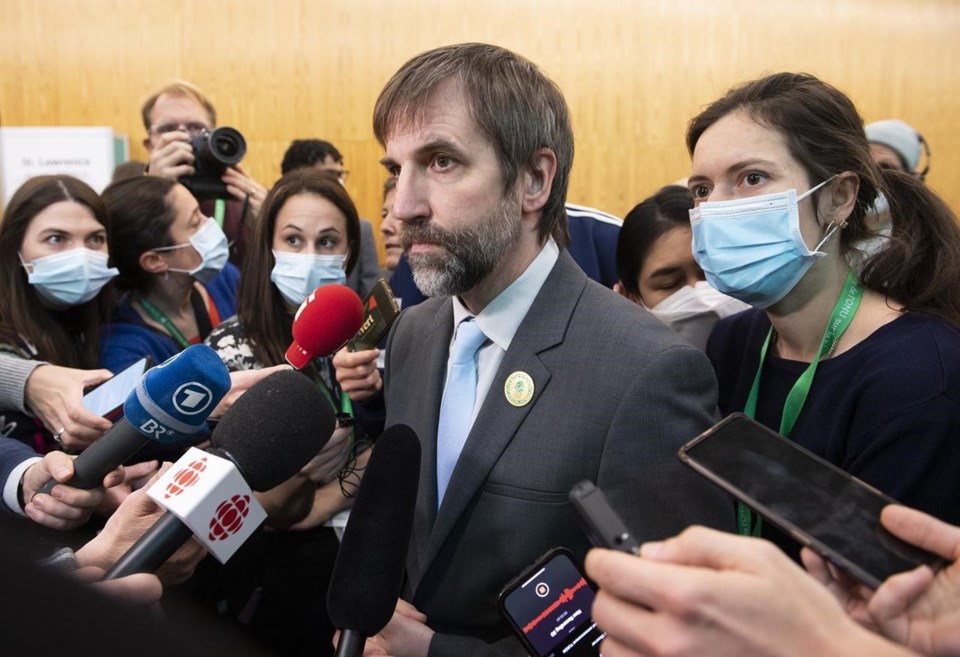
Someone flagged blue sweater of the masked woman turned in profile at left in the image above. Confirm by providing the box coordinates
[100,262,240,373]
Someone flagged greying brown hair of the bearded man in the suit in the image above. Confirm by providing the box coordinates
[373,43,573,247]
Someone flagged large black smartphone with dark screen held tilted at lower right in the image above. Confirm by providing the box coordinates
[678,413,943,588]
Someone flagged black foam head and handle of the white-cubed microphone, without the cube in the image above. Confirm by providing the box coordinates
[103,370,336,580]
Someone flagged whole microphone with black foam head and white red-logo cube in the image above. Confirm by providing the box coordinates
[105,370,336,579]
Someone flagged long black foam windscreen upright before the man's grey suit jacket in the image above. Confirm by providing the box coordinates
[327,424,420,637]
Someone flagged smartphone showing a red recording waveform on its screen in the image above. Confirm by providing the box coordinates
[497,548,606,657]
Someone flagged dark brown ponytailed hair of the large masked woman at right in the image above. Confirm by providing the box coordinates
[687,73,960,325]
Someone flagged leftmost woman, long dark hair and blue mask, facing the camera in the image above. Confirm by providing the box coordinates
[0,175,117,453]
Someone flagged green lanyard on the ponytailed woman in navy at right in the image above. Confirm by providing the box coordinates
[737,270,863,536]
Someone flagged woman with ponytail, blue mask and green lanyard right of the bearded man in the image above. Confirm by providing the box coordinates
[687,73,960,553]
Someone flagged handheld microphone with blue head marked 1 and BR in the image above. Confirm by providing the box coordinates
[39,344,230,494]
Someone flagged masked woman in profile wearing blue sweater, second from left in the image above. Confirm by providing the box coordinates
[100,176,240,371]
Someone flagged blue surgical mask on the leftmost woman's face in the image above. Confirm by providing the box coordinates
[20,247,120,306]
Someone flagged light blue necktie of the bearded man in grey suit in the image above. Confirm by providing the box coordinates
[437,317,487,508]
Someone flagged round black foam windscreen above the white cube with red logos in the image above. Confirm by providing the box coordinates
[209,370,337,491]
